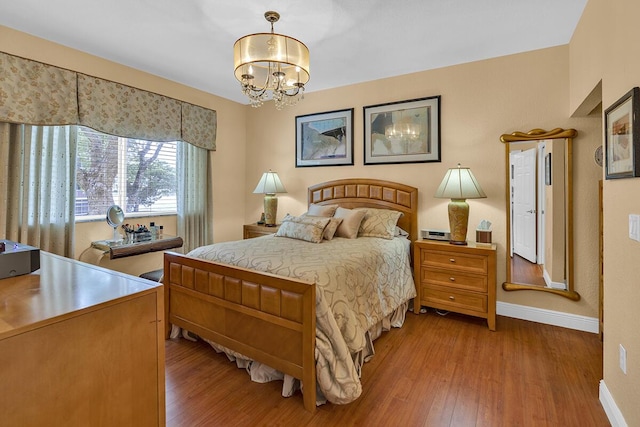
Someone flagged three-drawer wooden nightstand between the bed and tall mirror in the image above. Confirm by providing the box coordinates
[413,240,496,331]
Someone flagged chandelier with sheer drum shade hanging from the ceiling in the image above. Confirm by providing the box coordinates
[233,11,309,110]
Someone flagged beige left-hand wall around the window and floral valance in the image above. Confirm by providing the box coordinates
[0,26,246,274]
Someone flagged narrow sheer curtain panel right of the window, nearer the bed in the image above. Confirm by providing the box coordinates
[177,142,213,253]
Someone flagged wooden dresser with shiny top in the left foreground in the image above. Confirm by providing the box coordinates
[0,252,165,426]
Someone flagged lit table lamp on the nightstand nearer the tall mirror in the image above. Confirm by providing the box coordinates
[435,163,487,245]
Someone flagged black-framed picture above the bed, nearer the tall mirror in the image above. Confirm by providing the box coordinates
[364,96,440,165]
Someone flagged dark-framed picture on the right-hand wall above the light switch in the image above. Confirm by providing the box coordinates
[604,87,640,179]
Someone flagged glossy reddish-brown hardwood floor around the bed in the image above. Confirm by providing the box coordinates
[166,310,609,427]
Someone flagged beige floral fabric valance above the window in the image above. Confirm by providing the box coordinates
[0,52,217,150]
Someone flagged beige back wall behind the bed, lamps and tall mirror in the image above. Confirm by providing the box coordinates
[245,46,601,317]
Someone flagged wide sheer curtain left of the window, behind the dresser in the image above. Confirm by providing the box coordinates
[0,123,76,257]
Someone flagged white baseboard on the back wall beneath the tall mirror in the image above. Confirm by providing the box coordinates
[496,301,600,334]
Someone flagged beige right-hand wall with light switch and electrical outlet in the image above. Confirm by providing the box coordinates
[570,0,640,426]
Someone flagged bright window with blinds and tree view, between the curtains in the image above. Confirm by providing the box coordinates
[75,126,179,218]
